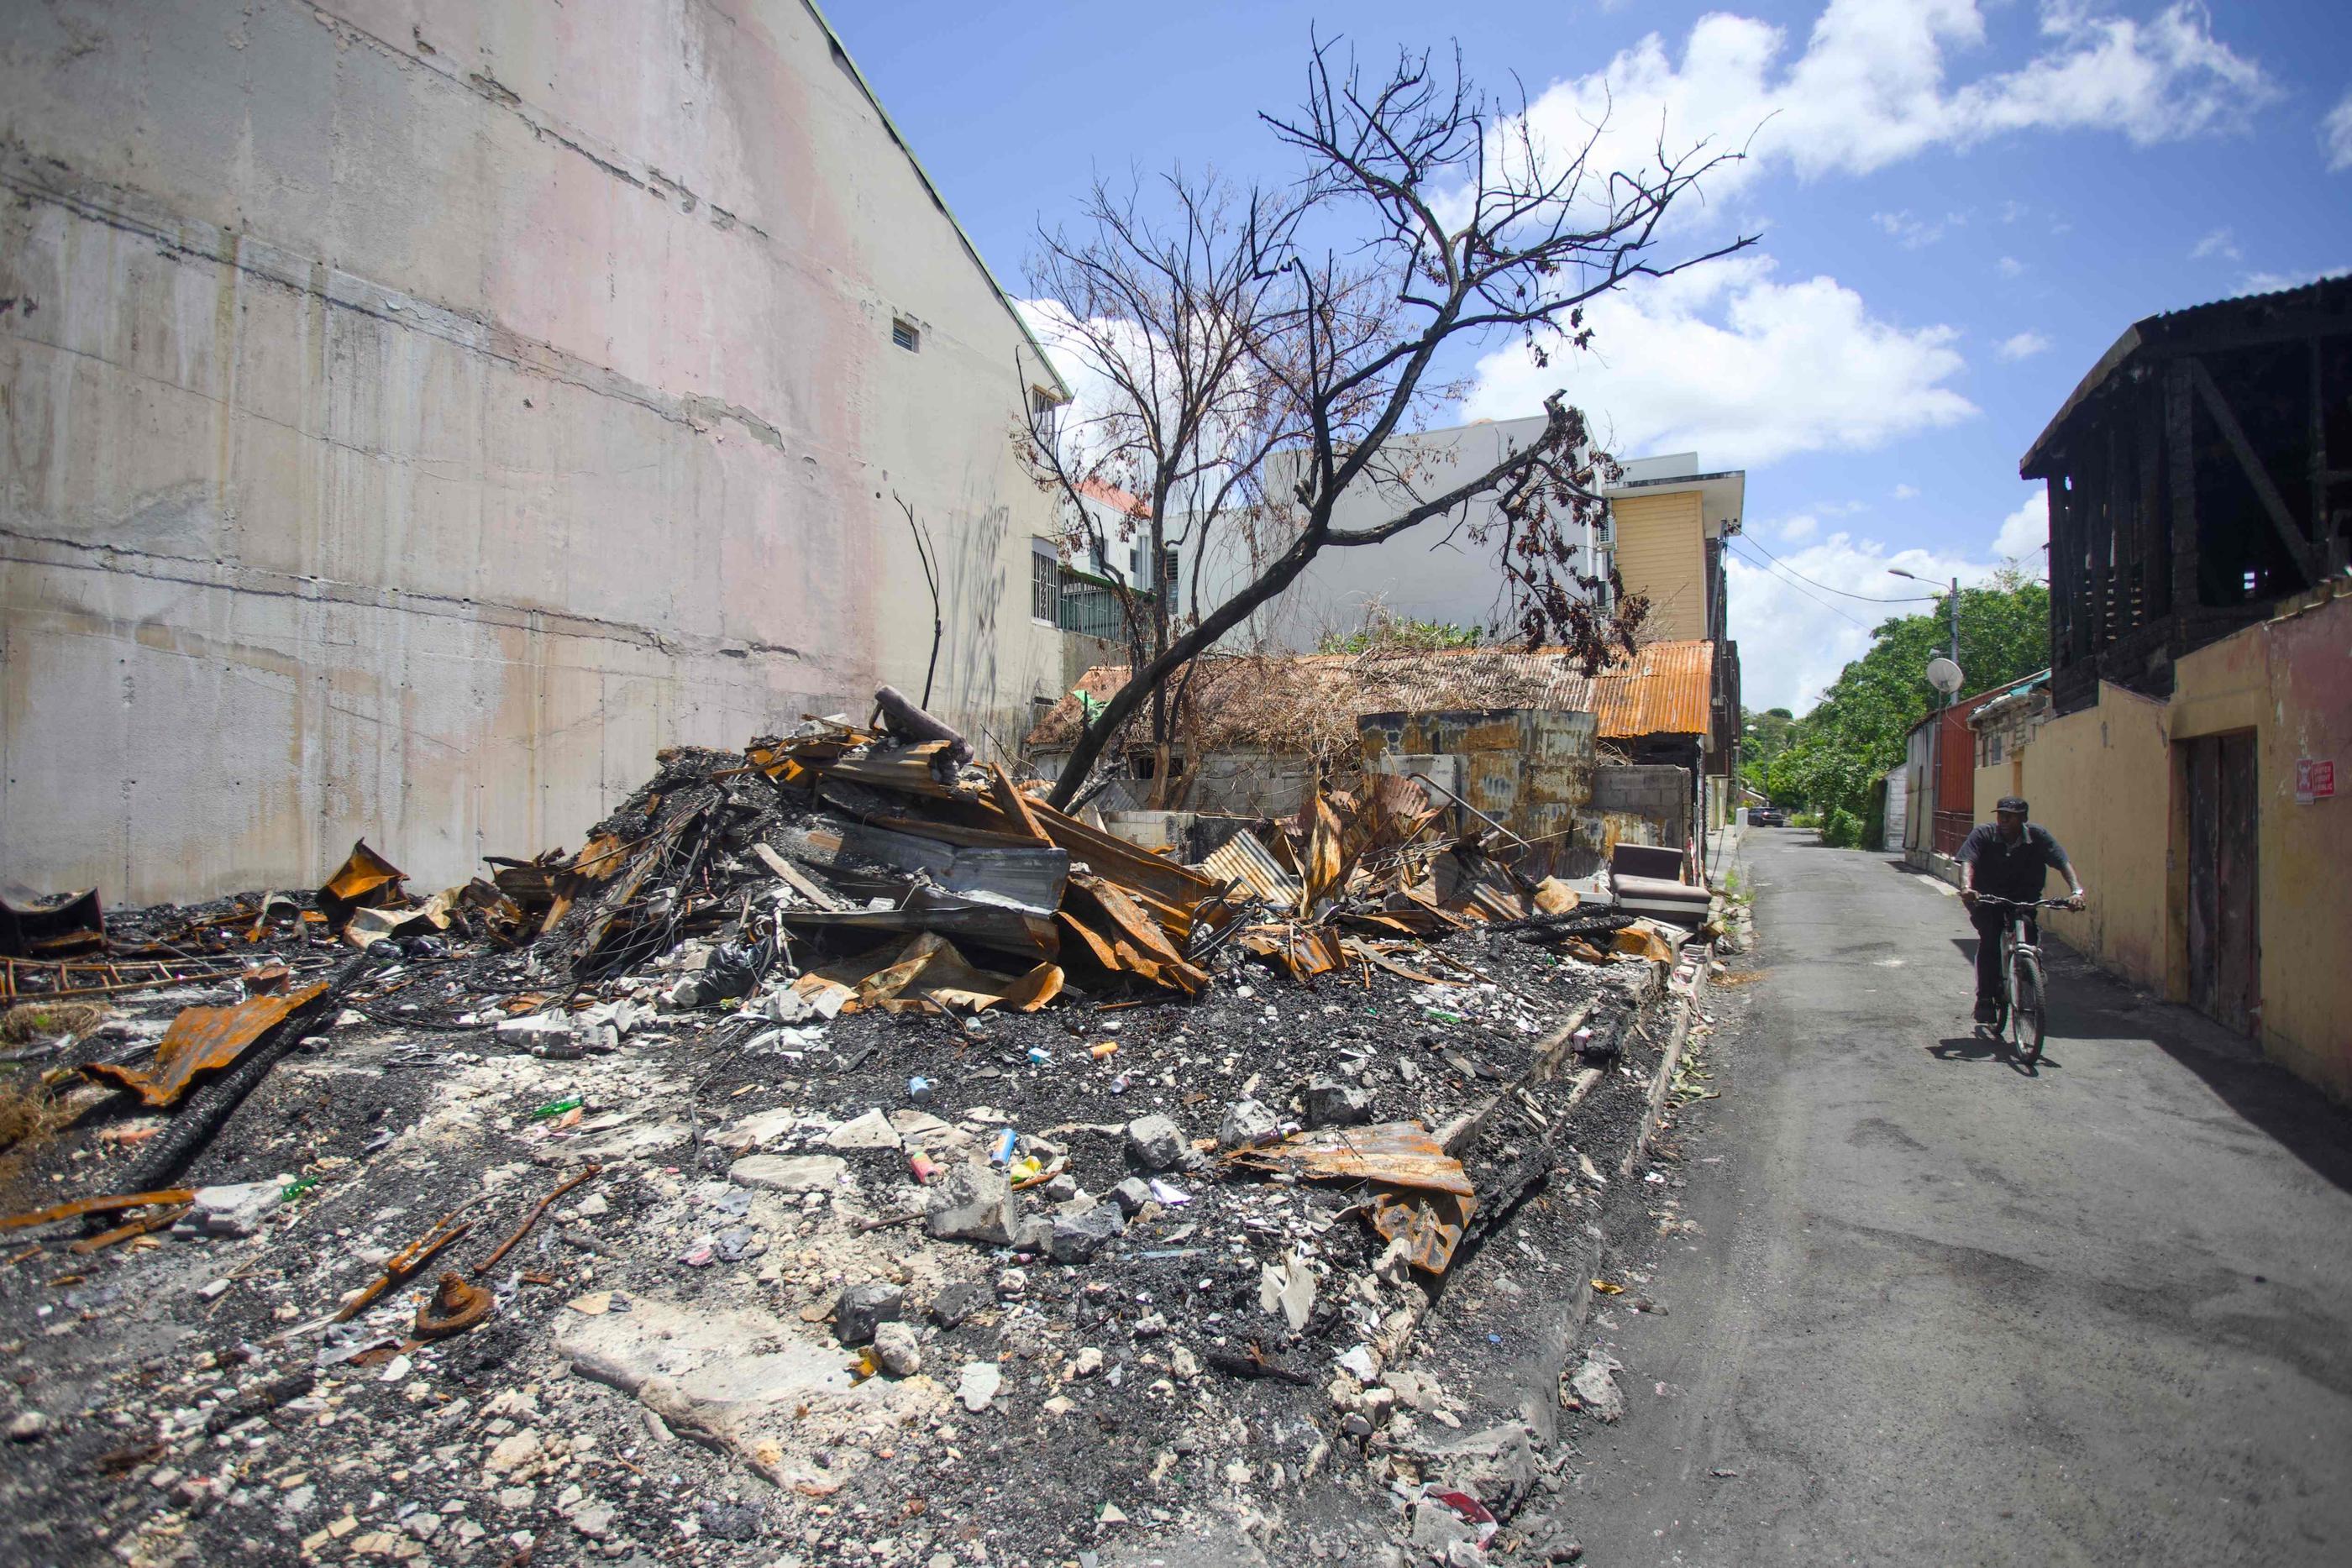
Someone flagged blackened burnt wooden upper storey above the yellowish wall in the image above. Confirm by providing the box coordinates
[2018,277,2352,712]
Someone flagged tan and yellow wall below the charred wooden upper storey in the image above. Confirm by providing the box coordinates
[1978,597,2352,1100]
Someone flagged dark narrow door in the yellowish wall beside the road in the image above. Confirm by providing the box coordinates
[2187,732,2263,1035]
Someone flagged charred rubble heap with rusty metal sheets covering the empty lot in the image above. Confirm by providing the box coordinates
[0,694,1698,1565]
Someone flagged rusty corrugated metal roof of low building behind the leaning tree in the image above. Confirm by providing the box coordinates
[1026,639,1714,753]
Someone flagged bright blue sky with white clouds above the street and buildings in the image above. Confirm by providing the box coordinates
[832,0,2352,710]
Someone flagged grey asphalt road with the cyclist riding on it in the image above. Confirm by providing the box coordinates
[1562,830,2352,1568]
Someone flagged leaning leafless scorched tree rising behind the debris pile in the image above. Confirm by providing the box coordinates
[1023,42,1755,806]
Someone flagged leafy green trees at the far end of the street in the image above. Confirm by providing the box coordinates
[1767,569,2051,836]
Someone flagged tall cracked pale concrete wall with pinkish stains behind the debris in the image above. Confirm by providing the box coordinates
[0,0,1063,903]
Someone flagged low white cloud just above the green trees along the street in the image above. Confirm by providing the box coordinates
[1724,486,2049,712]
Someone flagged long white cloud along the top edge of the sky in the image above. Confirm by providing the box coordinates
[1495,0,2275,215]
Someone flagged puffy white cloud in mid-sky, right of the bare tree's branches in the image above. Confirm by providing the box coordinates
[1463,254,1976,463]
